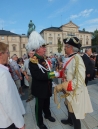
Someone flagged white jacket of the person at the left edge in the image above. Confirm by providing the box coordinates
[0,64,25,128]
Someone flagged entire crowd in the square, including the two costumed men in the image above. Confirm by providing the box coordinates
[0,31,98,129]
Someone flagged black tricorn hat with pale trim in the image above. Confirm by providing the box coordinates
[63,37,82,49]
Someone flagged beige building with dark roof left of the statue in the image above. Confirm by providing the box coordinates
[0,30,28,57]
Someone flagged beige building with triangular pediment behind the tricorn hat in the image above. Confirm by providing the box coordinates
[40,21,92,56]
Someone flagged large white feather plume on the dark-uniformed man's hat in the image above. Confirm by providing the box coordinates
[26,31,45,51]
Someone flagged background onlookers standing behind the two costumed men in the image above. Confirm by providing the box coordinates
[5,48,98,92]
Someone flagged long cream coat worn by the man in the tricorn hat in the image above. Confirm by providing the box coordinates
[65,54,93,119]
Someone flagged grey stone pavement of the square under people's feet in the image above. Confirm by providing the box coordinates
[23,80,98,129]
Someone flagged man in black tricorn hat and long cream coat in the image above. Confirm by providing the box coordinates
[54,37,93,129]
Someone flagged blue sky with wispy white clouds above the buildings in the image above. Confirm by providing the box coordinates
[0,0,98,34]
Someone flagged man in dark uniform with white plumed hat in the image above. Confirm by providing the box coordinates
[26,31,59,129]
